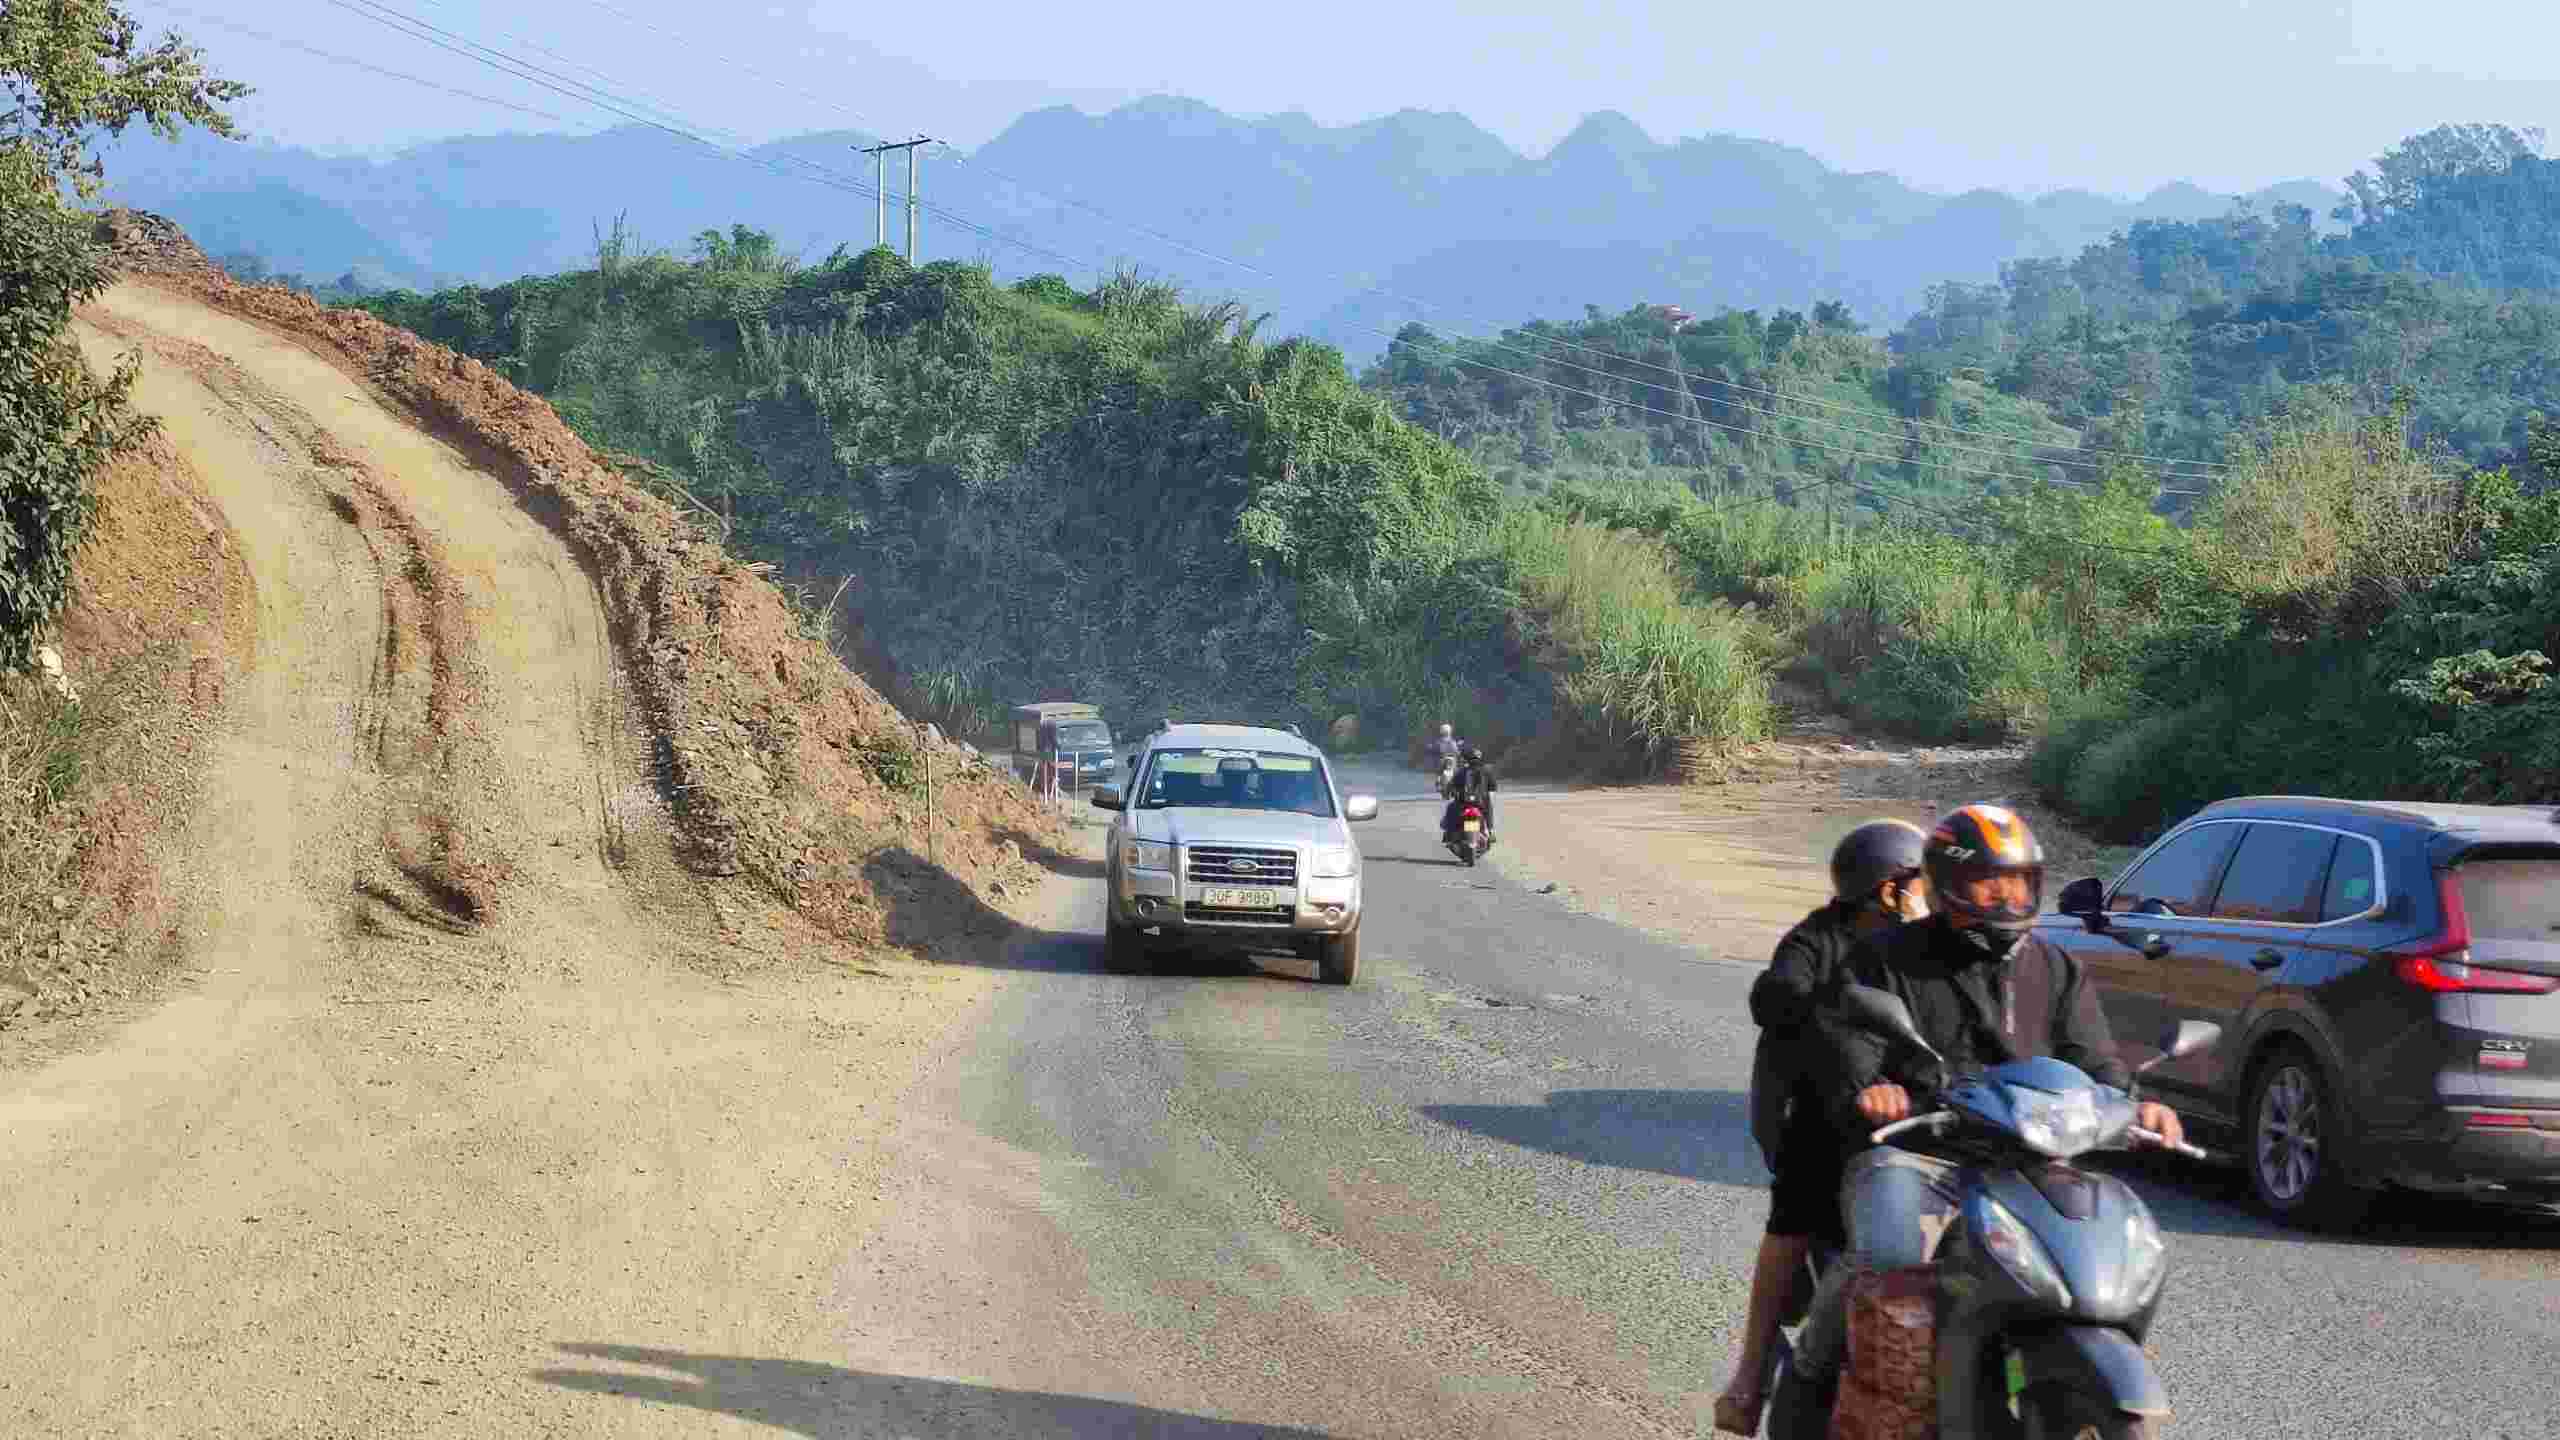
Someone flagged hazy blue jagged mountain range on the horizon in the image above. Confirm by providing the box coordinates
[108,97,2342,356]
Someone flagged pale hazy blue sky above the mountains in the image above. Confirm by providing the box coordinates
[149,0,2560,195]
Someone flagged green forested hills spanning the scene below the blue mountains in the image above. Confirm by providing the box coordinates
[320,126,2560,835]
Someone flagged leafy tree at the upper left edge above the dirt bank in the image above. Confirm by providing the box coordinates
[0,0,248,669]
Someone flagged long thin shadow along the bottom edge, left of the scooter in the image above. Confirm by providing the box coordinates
[532,1345,1324,1440]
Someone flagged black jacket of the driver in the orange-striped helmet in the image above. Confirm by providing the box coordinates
[1815,920,2130,1127]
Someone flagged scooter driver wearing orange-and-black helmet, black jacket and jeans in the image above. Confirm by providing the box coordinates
[1769,805,2184,1440]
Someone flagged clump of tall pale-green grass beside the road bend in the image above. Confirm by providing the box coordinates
[1498,512,1774,771]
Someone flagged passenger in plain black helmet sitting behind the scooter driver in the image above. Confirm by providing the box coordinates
[1715,820,1928,1435]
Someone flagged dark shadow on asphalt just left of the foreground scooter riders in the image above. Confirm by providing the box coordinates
[1423,1089,1769,1184]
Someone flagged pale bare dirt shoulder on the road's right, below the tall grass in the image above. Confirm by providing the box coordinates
[1490,702,2132,966]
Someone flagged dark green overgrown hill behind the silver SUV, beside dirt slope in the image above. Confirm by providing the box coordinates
[366,228,1748,758]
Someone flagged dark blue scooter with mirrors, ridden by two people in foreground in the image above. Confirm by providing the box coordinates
[1777,986,2222,1440]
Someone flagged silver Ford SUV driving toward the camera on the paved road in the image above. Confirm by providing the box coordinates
[1093,725,1377,984]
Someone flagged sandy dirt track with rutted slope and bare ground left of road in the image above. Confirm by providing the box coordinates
[0,215,1073,1437]
